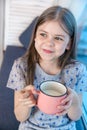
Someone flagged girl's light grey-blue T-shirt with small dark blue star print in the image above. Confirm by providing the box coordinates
[7,58,87,130]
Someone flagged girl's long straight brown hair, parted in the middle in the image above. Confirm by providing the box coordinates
[26,6,77,84]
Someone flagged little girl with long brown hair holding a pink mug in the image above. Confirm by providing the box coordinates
[7,6,87,130]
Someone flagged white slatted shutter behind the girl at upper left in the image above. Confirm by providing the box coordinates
[4,0,54,49]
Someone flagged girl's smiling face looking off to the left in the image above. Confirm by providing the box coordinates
[35,21,70,62]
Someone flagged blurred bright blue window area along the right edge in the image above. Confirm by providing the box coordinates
[77,3,87,129]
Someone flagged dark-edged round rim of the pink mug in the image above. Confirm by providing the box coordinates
[40,80,68,97]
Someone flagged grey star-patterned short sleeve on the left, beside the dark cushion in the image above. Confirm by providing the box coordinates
[7,60,26,90]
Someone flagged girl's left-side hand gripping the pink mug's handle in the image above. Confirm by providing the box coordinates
[19,85,36,108]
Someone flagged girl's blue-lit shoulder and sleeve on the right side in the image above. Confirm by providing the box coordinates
[63,60,87,93]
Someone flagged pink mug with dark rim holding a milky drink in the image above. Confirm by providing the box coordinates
[36,81,68,114]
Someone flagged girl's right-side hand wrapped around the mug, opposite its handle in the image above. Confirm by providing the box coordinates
[57,88,75,116]
